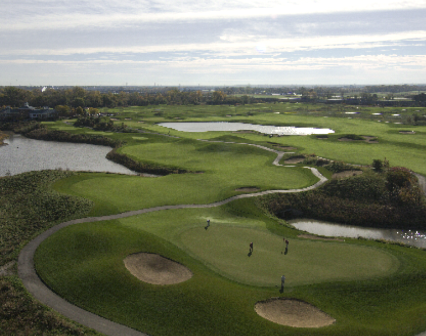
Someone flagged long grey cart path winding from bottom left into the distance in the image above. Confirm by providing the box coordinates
[18,135,426,336]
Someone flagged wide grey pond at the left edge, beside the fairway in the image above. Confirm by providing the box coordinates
[0,135,136,176]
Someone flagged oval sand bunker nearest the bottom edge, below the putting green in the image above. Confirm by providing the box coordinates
[254,298,336,328]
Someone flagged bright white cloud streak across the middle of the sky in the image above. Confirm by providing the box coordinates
[0,30,426,57]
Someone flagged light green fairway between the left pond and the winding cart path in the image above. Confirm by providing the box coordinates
[56,140,318,214]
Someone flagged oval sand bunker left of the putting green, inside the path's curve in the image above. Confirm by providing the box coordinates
[124,253,192,285]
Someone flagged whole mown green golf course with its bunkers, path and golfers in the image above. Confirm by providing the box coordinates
[12,103,426,336]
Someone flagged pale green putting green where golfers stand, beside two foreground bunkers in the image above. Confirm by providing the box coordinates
[180,226,399,286]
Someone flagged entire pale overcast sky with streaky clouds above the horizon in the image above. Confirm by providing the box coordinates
[0,0,426,86]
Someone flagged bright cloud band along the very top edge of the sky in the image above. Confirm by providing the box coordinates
[0,0,426,31]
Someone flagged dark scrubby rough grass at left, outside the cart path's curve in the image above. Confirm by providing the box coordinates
[0,171,98,336]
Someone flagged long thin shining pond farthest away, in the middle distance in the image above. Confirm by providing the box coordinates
[158,122,334,135]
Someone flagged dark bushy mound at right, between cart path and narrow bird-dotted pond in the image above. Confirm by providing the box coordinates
[262,170,426,229]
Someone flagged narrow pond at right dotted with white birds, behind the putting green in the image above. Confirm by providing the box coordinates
[289,219,426,248]
